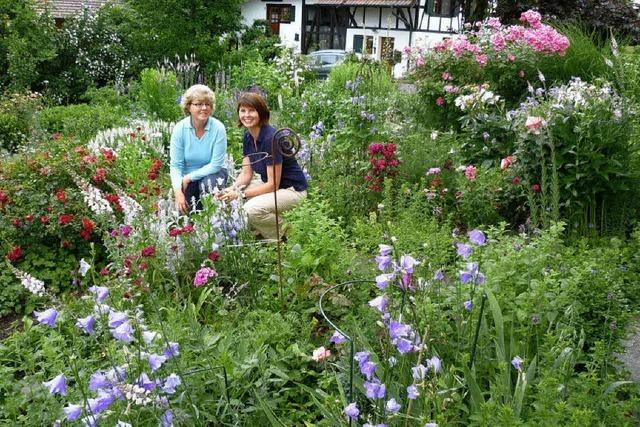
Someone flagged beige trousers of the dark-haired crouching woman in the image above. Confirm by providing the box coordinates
[243,187,307,240]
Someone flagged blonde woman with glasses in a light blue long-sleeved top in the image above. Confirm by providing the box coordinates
[169,84,227,213]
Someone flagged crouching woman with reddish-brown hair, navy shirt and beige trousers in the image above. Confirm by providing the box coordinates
[219,92,307,240]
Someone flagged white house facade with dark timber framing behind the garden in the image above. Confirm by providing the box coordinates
[242,0,462,72]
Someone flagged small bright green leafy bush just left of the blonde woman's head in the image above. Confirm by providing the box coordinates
[138,68,182,122]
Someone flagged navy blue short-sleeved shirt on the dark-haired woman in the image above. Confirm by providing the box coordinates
[242,125,308,191]
